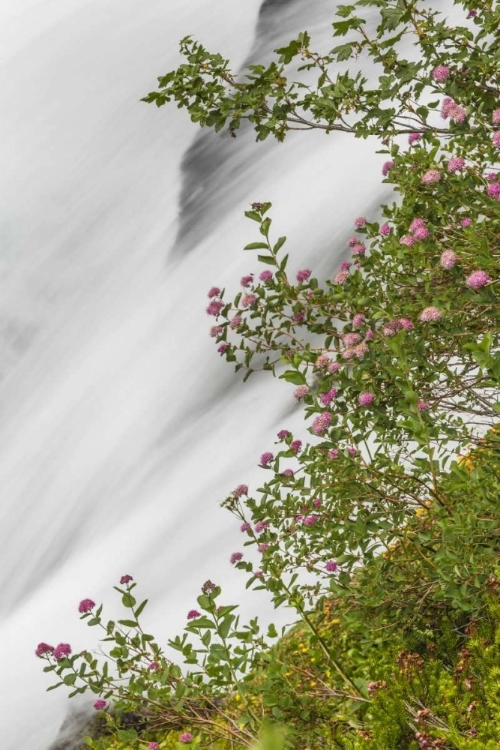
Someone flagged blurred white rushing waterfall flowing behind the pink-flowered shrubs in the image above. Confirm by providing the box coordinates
[0,0,390,750]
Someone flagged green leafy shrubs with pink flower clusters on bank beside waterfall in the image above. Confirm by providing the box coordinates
[36,0,500,750]
